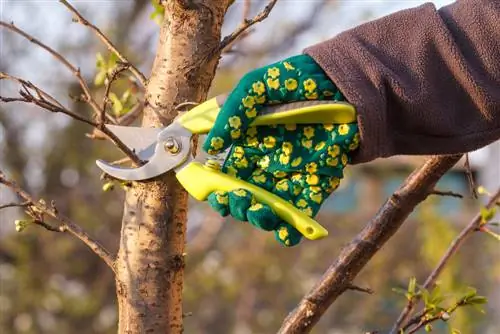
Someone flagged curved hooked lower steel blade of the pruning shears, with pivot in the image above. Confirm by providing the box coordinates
[96,122,191,181]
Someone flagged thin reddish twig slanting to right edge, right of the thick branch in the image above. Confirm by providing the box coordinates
[391,189,500,334]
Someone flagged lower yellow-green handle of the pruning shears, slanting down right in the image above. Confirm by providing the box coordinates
[176,162,328,240]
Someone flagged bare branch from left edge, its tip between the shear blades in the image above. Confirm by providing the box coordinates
[0,72,142,165]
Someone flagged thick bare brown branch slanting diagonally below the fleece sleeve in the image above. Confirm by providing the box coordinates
[279,155,461,333]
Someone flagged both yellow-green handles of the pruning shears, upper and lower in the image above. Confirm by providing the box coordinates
[177,96,356,240]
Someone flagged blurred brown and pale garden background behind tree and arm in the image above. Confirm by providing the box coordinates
[0,0,500,334]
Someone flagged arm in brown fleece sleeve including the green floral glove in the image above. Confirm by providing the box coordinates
[204,0,500,246]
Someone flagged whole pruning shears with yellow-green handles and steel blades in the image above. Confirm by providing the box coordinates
[96,95,356,240]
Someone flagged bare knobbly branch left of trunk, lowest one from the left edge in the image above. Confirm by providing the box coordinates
[0,171,115,272]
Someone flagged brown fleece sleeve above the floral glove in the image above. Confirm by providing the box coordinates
[305,0,500,163]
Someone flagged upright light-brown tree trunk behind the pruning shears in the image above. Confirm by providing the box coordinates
[116,0,230,334]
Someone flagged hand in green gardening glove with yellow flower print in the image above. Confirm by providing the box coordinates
[203,55,359,246]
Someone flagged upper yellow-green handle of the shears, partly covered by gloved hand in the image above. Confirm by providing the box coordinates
[177,95,356,134]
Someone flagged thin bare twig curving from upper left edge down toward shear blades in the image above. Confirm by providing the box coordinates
[0,21,116,123]
